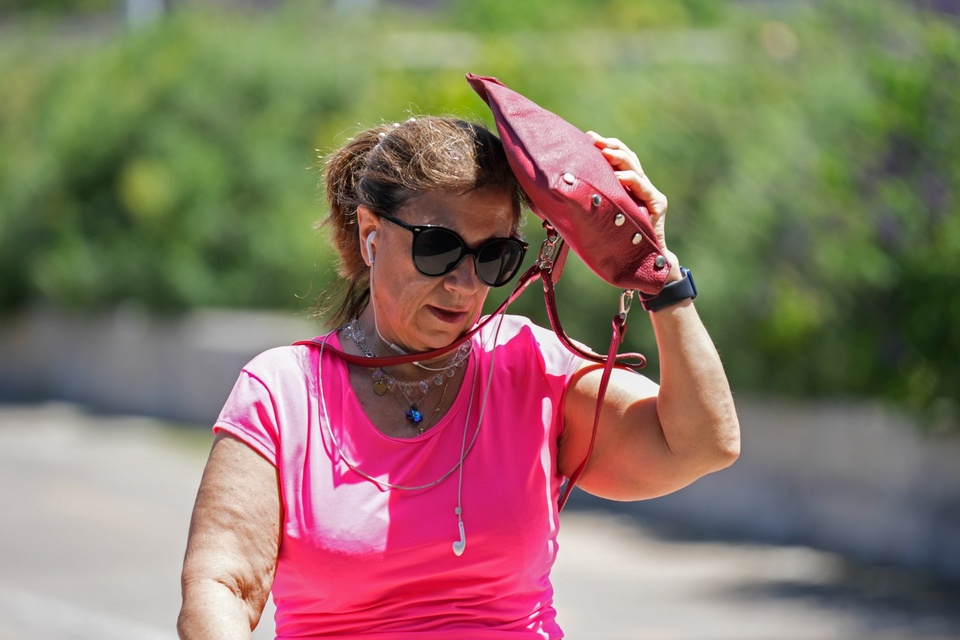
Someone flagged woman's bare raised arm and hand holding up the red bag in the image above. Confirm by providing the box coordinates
[559,134,740,500]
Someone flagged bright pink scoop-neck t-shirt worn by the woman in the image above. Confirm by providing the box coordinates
[215,316,582,639]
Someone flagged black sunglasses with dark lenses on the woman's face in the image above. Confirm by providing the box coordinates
[380,214,528,287]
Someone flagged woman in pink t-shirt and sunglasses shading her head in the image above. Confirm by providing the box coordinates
[178,118,739,639]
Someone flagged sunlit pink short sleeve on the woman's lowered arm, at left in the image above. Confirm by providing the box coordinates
[213,369,280,466]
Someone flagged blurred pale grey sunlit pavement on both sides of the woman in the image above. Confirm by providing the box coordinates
[0,405,960,640]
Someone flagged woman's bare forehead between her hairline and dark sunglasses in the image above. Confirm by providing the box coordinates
[400,189,514,240]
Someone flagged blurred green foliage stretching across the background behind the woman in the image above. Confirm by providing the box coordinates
[0,0,960,427]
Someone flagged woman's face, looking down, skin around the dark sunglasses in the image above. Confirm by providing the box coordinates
[358,189,513,355]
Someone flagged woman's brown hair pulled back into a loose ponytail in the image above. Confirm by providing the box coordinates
[315,116,525,326]
